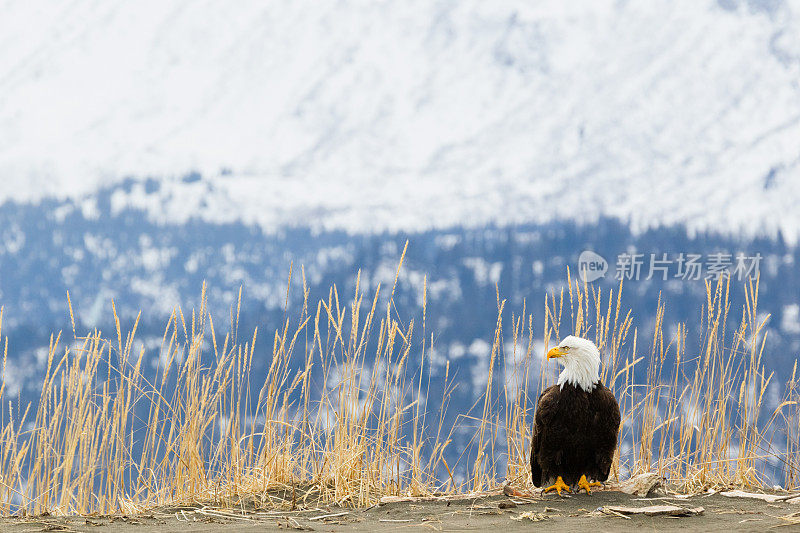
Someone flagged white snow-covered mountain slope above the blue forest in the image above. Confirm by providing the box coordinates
[0,0,800,240]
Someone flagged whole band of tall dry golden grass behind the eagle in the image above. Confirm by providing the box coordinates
[0,249,800,514]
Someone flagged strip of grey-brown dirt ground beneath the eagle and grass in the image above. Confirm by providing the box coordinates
[0,491,800,533]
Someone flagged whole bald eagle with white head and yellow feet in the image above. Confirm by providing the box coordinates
[531,335,620,494]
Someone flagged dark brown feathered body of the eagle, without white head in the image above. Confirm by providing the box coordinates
[531,382,620,487]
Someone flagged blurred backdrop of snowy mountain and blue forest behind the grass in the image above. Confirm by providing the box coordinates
[0,0,800,472]
